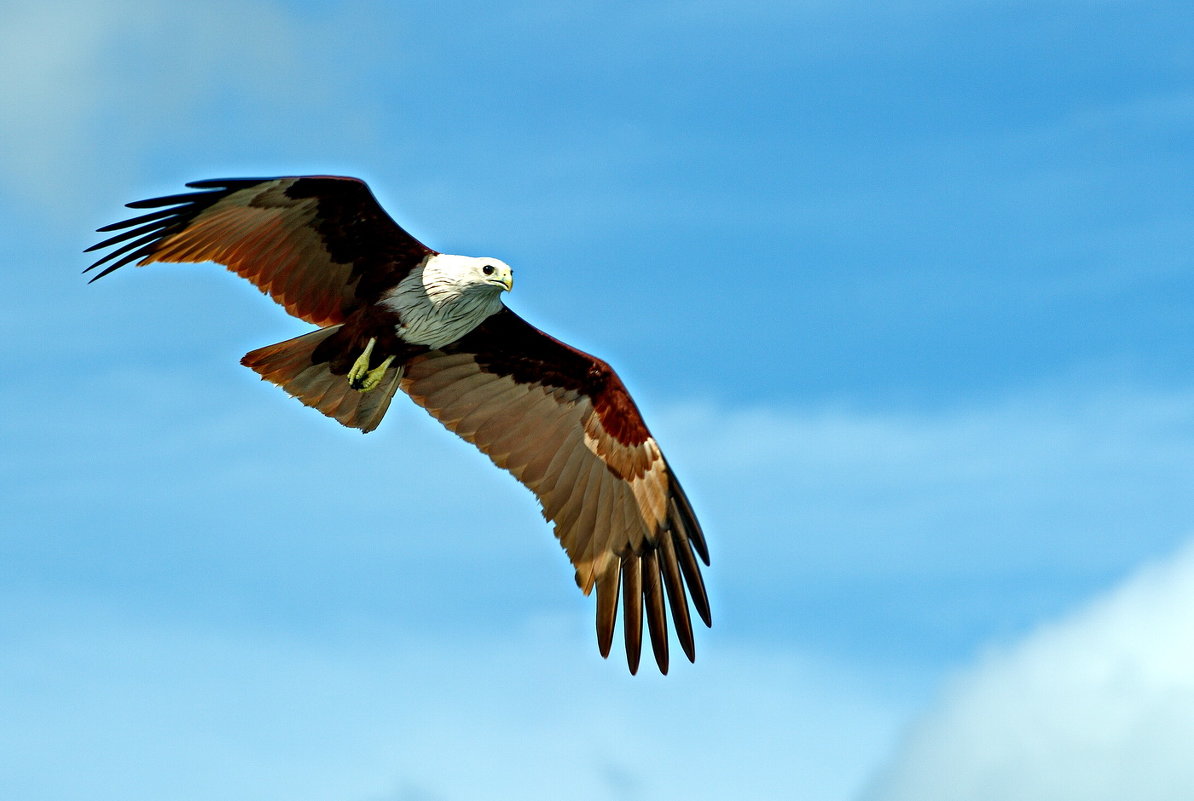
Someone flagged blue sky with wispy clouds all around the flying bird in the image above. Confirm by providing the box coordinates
[0,0,1194,801]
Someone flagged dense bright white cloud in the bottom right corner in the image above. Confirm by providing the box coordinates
[864,546,1194,801]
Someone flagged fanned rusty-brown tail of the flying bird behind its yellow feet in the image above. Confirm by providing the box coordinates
[240,326,402,432]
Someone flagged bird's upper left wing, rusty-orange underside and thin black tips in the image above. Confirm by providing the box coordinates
[85,175,435,326]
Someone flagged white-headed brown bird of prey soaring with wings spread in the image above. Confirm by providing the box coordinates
[85,175,712,673]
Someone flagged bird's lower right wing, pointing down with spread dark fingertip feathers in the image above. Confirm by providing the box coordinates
[401,309,710,673]
